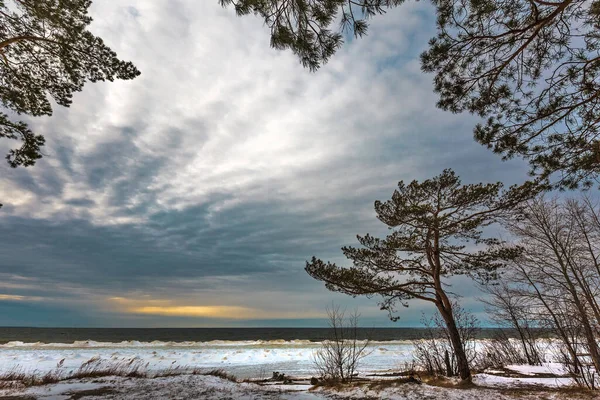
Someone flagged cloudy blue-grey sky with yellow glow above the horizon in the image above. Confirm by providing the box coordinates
[0,0,527,327]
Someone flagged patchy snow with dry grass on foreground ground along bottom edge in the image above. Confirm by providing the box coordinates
[5,375,577,400]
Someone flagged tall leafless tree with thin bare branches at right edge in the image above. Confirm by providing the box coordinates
[508,197,600,387]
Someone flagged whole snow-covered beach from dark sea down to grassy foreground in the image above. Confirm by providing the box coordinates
[0,340,587,400]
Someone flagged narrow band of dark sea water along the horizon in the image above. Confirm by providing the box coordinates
[0,328,512,344]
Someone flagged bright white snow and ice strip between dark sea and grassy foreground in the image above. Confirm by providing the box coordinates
[0,340,413,378]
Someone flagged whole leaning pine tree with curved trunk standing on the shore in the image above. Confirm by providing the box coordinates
[306,170,536,380]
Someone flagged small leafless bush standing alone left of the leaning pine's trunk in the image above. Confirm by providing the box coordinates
[313,304,369,382]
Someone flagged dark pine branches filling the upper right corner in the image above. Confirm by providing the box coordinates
[421,0,600,188]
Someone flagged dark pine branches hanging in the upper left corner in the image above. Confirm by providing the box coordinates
[0,0,140,167]
